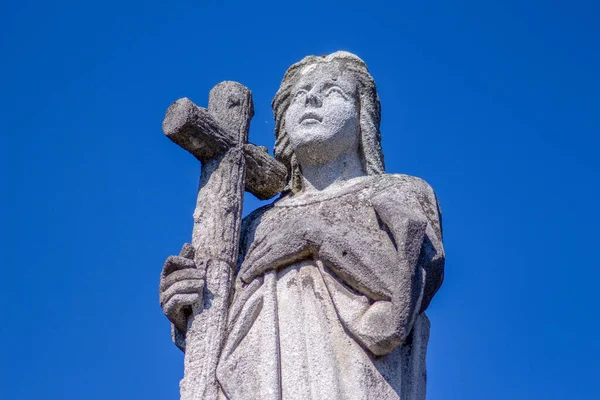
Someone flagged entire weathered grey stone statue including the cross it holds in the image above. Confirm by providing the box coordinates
[160,52,444,400]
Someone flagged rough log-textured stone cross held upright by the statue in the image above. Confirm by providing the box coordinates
[163,81,287,400]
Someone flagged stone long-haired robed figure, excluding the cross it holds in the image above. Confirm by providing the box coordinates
[161,51,445,400]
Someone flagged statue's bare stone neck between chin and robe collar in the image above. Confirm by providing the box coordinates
[300,151,365,194]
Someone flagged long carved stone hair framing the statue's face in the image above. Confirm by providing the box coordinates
[272,51,385,192]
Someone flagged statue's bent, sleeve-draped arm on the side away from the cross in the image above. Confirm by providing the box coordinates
[342,178,444,355]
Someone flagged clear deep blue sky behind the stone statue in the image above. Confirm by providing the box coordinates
[0,0,600,400]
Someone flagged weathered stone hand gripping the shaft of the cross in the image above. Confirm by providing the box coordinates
[159,243,205,332]
